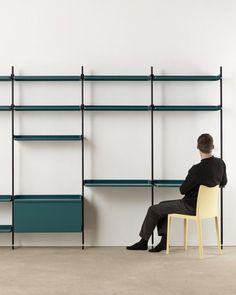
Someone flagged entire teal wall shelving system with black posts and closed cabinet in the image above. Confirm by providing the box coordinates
[0,67,223,249]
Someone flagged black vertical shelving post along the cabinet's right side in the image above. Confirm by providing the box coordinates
[81,66,84,249]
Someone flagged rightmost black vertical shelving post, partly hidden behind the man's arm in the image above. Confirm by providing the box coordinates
[220,67,224,249]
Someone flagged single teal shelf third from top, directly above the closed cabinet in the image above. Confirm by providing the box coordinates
[14,135,82,141]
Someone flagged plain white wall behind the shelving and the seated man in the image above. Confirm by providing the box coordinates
[0,0,236,245]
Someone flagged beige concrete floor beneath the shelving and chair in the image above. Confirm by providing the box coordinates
[0,247,236,295]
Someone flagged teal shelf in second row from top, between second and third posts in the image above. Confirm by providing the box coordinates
[84,105,151,111]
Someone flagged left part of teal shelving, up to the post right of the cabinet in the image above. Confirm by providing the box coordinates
[0,67,84,249]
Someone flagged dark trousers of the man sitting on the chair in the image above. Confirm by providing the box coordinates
[139,199,196,240]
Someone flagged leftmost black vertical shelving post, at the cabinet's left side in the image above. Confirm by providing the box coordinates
[11,66,15,249]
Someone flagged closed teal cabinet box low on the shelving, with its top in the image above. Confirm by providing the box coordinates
[14,195,82,232]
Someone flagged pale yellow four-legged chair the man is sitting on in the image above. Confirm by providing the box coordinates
[166,185,222,258]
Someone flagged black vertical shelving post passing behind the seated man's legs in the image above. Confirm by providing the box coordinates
[151,67,154,247]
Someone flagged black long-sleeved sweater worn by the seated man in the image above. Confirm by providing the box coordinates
[180,156,227,209]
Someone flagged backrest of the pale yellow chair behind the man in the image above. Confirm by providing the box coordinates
[196,185,219,218]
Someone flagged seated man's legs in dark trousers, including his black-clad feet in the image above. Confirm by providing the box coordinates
[127,200,195,252]
